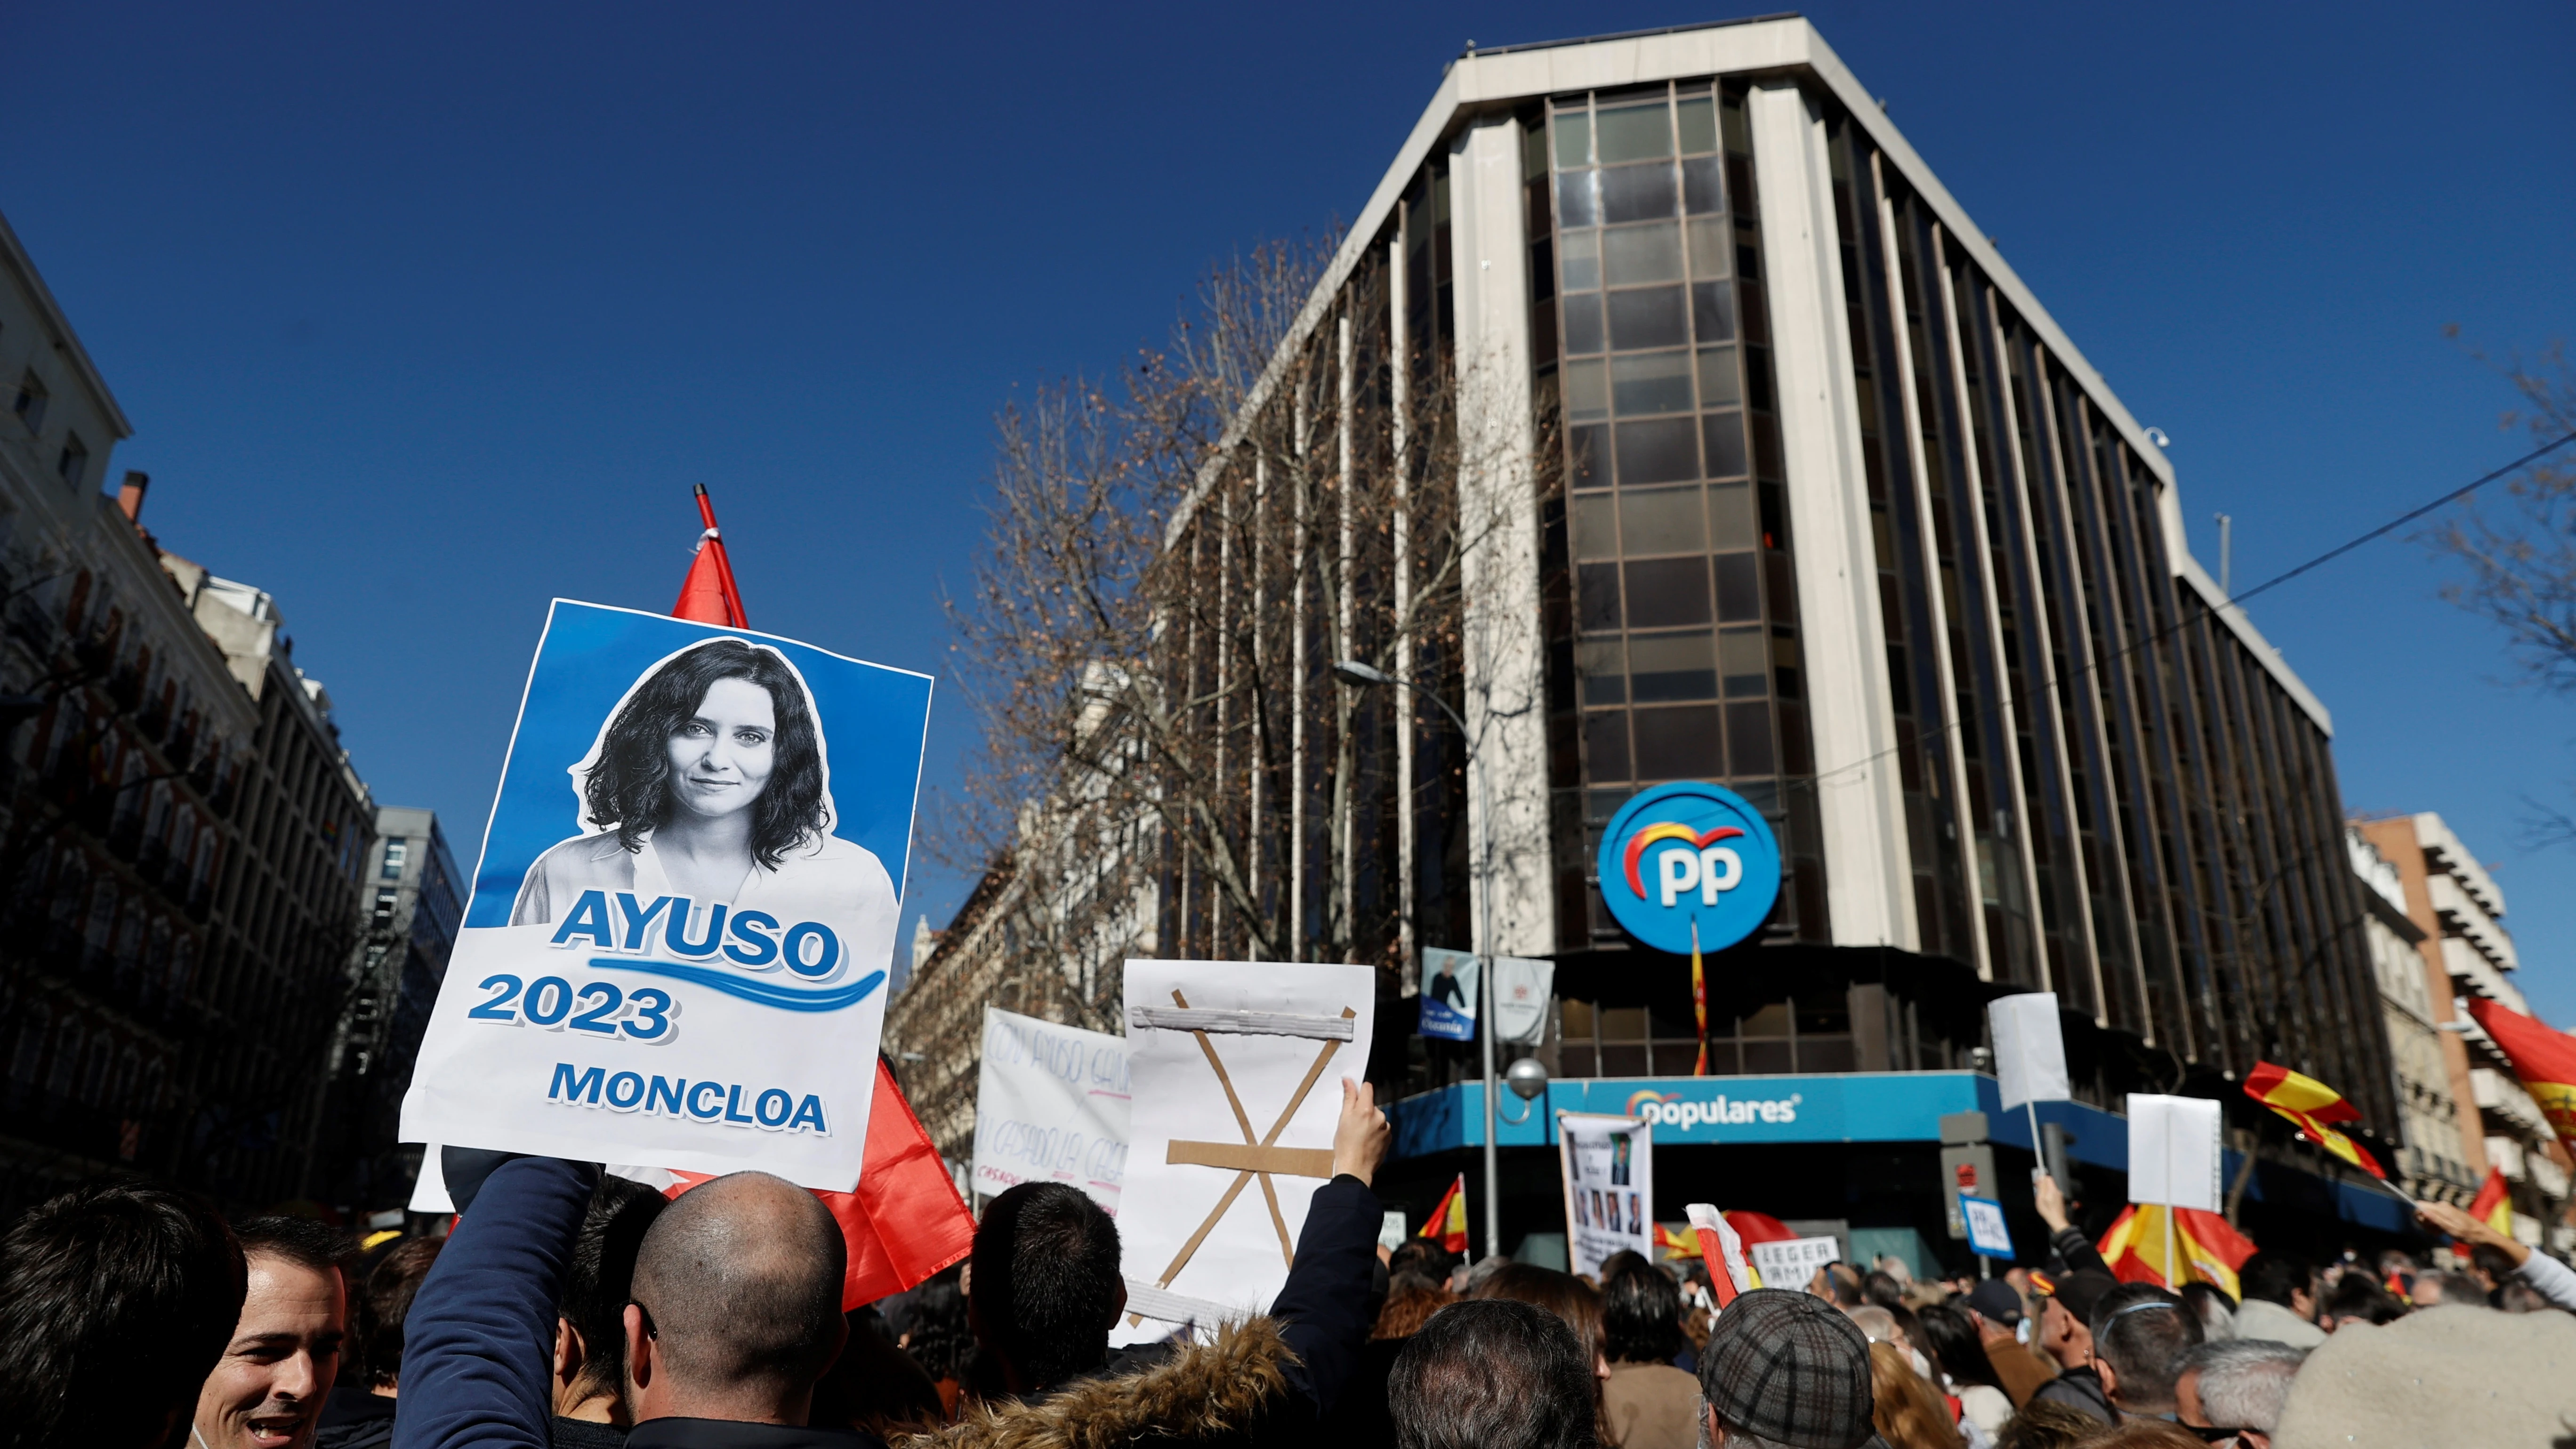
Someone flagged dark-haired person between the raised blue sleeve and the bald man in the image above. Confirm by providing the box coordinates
[554,1178,667,1449]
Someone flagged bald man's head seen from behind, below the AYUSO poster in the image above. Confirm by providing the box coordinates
[634,1173,845,1395]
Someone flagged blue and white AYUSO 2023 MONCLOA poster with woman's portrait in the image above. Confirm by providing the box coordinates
[402,598,930,1191]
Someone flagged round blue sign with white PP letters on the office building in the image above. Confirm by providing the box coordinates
[1600,781,1780,957]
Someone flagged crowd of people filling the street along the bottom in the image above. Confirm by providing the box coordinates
[0,1083,2576,1449]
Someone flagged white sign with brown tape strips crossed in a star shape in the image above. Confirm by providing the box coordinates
[1110,962,1378,1343]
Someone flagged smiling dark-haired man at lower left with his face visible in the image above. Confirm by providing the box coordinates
[193,1217,350,1449]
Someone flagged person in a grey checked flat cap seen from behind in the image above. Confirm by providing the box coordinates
[1690,1289,1876,1449]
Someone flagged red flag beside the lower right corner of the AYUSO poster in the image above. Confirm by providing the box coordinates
[665,1057,974,1312]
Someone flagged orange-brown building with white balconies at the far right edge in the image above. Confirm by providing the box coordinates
[2354,812,2576,1253]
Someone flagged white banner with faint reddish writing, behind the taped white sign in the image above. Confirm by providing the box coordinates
[974,1006,1128,1217]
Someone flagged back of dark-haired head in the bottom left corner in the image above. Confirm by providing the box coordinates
[0,1183,245,1449]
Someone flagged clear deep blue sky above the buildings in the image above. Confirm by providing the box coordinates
[0,0,2576,1023]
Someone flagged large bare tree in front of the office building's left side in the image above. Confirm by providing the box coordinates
[935,237,1554,1026]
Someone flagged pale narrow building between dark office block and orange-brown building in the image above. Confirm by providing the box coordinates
[2344,830,2478,1204]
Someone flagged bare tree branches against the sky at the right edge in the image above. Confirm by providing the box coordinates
[2424,328,2576,843]
